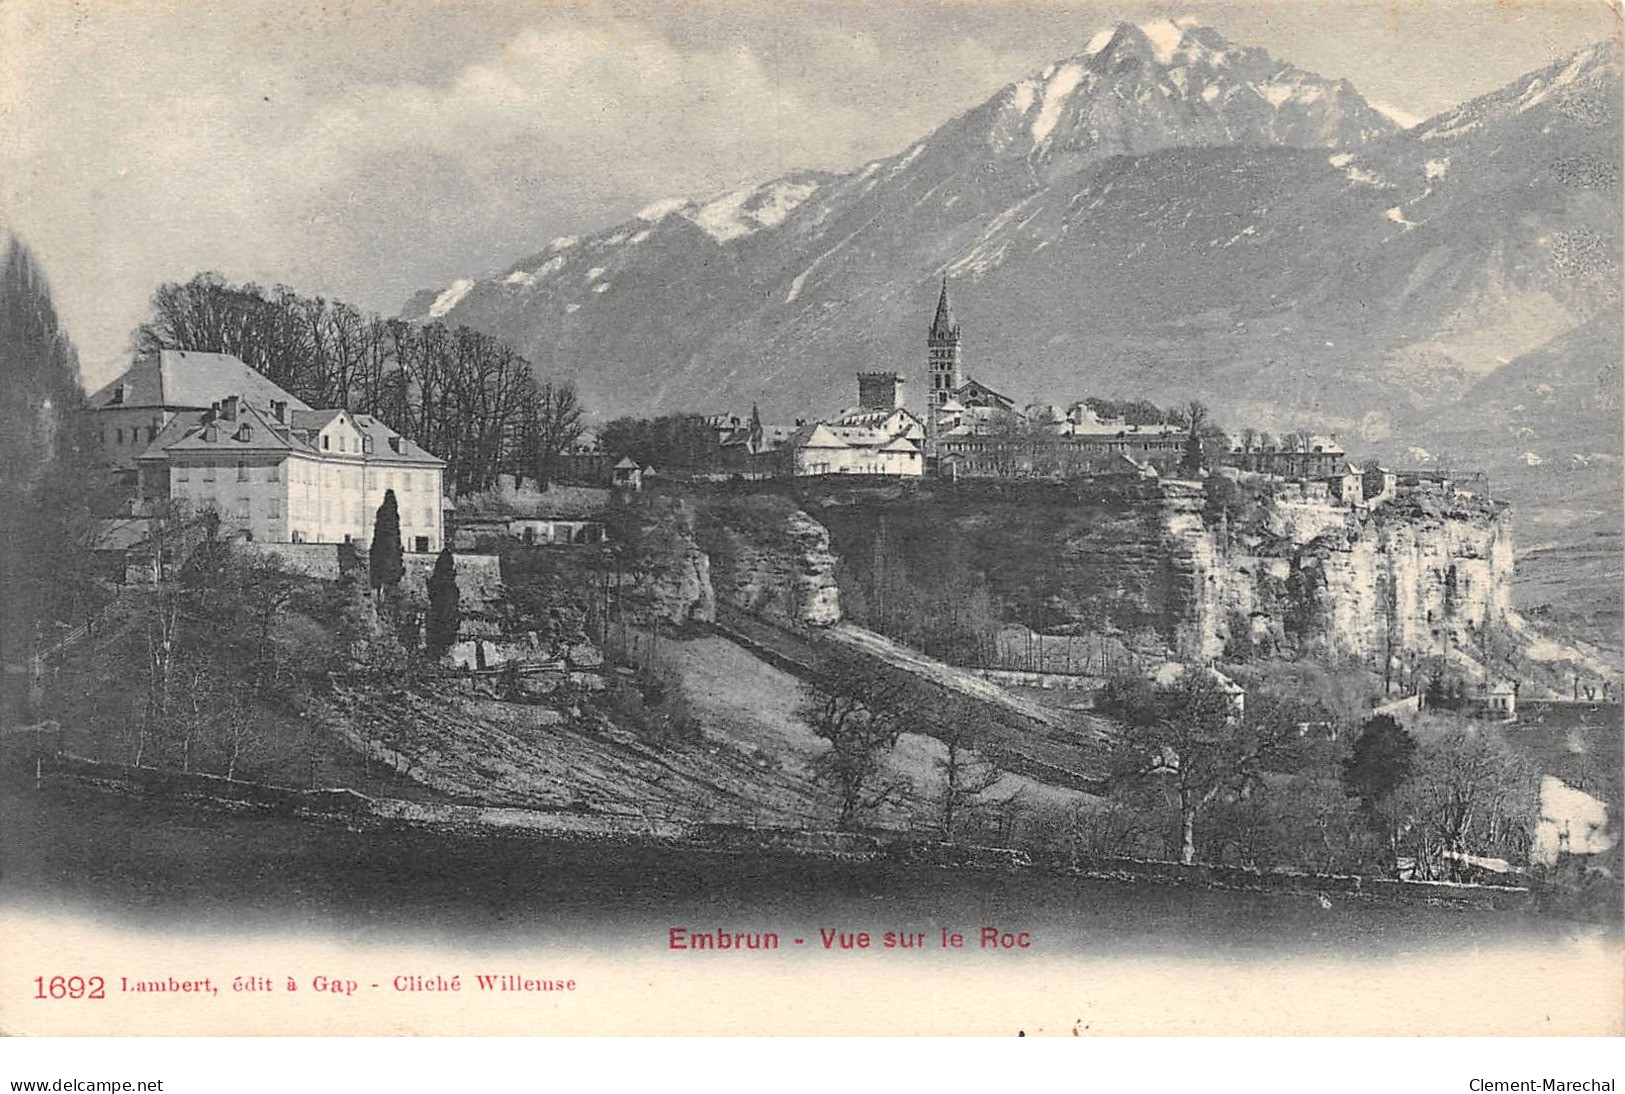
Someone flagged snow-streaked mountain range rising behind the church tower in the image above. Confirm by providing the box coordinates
[405,21,1620,481]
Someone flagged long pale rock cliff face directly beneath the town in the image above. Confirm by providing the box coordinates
[780,476,1513,668]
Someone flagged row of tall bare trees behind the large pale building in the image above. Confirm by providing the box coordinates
[135,273,583,493]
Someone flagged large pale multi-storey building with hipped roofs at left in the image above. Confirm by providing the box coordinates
[88,351,445,551]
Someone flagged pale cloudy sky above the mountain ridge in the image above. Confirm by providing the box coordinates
[0,0,1619,387]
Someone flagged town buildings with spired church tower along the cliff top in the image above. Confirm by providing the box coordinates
[564,276,1484,506]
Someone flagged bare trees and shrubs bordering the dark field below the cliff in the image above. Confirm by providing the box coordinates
[800,652,1537,879]
